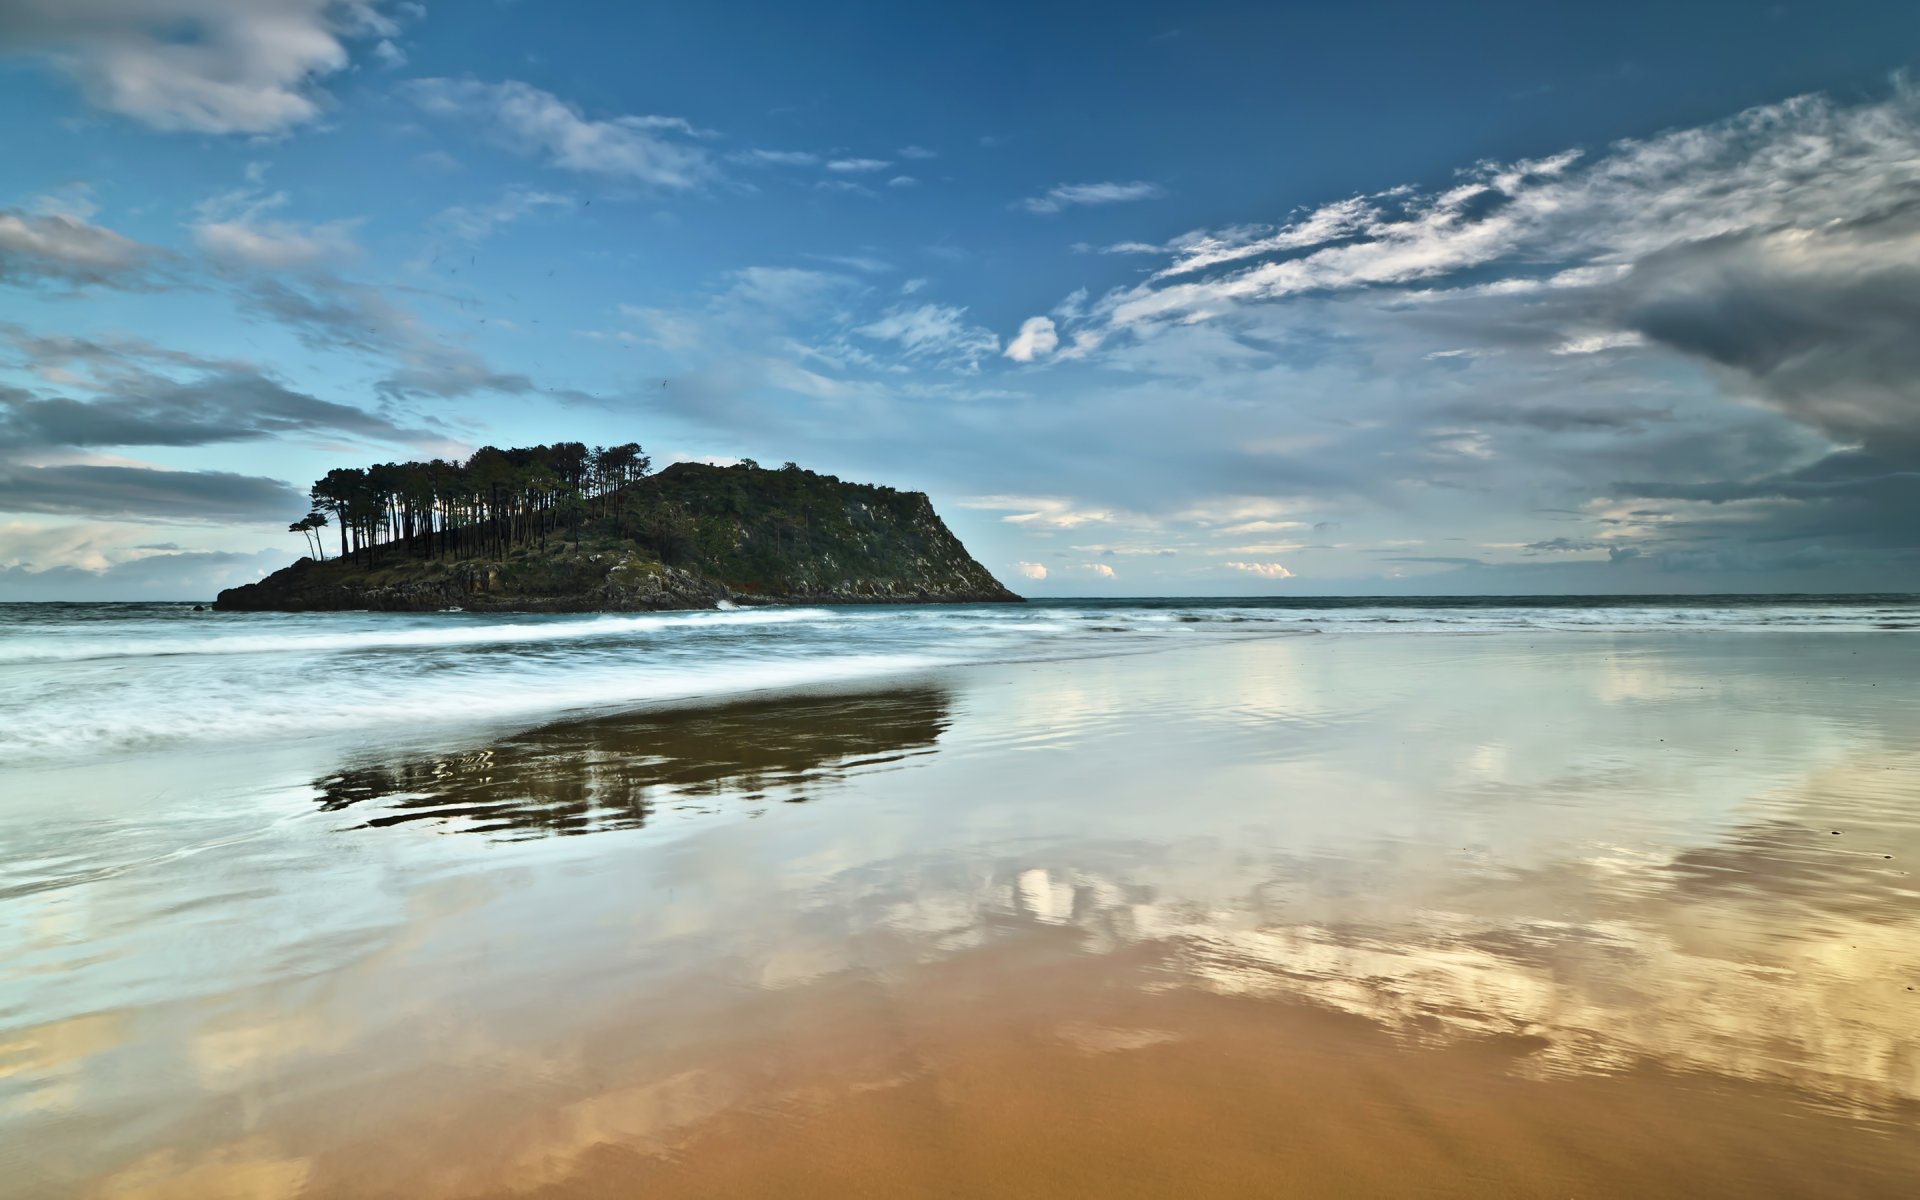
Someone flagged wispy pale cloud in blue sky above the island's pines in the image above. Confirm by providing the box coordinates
[405,79,716,190]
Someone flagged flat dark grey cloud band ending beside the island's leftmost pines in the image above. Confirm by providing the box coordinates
[0,463,307,524]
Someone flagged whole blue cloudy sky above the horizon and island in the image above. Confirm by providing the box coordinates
[0,0,1920,599]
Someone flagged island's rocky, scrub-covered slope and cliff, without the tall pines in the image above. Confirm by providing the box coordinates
[213,463,1020,612]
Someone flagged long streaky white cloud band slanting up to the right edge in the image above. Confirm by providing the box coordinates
[1102,86,1920,332]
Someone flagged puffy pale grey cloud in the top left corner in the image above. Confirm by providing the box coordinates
[0,0,397,134]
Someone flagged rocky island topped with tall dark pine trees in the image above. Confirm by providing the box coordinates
[213,442,1021,612]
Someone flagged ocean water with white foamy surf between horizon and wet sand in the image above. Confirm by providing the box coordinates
[0,595,1920,766]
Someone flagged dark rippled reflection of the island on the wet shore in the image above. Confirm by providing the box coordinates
[313,687,950,839]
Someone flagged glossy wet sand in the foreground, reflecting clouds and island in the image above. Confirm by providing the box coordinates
[0,634,1920,1198]
